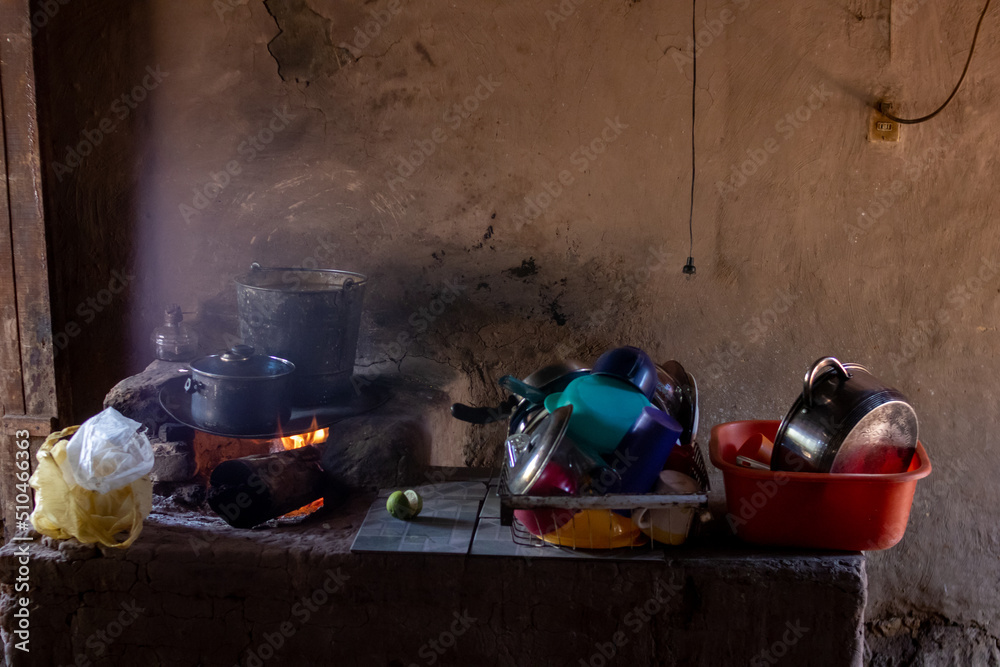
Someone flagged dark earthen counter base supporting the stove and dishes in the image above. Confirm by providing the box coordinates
[0,493,867,666]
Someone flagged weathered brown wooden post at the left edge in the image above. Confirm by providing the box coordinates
[0,0,58,537]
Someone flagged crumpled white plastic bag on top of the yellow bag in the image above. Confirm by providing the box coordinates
[64,408,153,493]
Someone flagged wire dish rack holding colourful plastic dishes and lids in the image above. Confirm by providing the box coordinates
[497,443,711,550]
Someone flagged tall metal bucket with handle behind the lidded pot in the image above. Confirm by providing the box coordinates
[236,262,368,406]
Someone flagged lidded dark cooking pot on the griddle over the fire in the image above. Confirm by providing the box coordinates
[184,345,295,436]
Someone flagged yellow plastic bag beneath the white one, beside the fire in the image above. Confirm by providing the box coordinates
[30,426,153,548]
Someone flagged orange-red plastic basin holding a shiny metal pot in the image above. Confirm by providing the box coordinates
[709,421,931,551]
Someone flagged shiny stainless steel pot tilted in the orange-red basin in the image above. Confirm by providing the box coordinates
[771,357,917,473]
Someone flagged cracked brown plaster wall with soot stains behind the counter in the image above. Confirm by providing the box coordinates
[31,0,1000,652]
